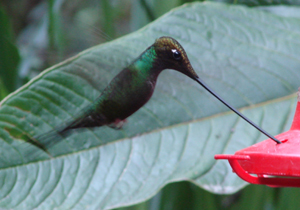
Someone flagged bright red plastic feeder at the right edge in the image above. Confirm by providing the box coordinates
[215,91,300,187]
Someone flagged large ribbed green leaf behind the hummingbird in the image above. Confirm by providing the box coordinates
[0,3,300,209]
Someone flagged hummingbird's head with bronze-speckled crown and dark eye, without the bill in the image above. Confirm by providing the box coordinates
[153,36,199,79]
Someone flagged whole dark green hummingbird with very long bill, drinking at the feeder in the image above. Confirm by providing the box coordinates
[30,36,281,154]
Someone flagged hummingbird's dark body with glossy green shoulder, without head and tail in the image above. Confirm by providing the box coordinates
[63,47,161,131]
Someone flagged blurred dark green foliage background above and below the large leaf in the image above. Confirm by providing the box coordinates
[0,0,300,210]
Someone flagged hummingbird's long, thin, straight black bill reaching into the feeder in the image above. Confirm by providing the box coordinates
[195,78,282,144]
